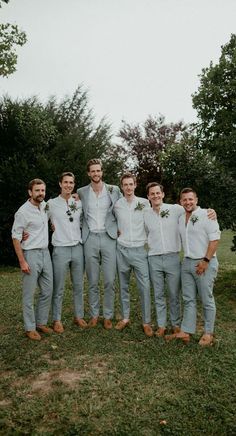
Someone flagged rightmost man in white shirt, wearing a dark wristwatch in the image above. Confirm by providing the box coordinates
[173,188,220,346]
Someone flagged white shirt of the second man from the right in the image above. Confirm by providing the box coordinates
[144,203,184,256]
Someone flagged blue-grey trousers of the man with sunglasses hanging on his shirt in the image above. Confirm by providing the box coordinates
[52,244,84,321]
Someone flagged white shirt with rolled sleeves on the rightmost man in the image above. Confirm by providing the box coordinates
[179,207,220,259]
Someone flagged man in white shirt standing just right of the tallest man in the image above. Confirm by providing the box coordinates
[114,173,153,336]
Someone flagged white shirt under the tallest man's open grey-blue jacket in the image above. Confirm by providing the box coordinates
[87,185,111,232]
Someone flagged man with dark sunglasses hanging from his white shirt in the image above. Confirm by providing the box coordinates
[47,172,87,333]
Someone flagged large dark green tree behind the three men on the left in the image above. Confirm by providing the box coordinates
[0,87,123,264]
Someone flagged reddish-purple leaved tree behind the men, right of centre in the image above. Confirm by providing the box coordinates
[119,115,187,196]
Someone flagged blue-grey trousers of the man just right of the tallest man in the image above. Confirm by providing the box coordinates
[117,243,151,324]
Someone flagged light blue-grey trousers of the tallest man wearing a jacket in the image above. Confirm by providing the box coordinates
[84,232,116,319]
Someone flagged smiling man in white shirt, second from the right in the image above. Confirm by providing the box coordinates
[144,182,184,337]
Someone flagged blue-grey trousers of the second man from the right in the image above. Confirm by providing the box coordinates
[148,253,181,327]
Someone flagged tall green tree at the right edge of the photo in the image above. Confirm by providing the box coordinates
[193,34,236,247]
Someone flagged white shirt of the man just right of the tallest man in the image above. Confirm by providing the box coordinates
[114,197,150,247]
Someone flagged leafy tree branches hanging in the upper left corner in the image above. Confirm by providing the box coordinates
[0,0,27,77]
